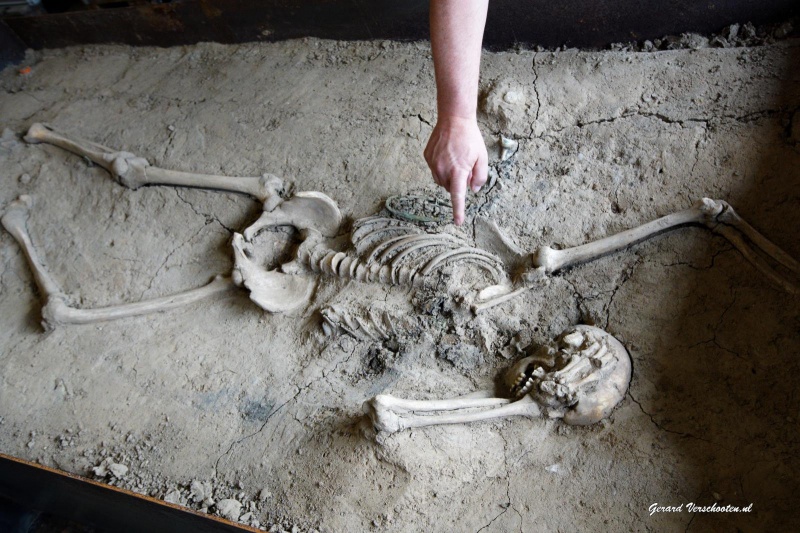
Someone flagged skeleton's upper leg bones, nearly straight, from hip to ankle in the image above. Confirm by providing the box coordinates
[25,123,283,206]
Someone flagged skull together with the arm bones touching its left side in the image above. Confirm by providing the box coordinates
[364,325,631,433]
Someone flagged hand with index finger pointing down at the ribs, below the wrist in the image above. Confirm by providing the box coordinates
[424,116,489,226]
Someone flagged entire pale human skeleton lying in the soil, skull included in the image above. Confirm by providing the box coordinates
[1,120,800,432]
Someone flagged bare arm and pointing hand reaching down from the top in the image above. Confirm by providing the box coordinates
[425,0,489,224]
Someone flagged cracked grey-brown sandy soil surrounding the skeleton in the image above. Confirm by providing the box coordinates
[0,35,800,531]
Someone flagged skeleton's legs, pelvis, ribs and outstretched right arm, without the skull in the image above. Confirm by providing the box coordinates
[2,124,800,329]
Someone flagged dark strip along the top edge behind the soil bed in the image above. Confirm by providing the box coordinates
[0,0,800,67]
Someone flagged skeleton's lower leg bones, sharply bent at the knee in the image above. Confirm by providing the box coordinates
[0,195,233,331]
